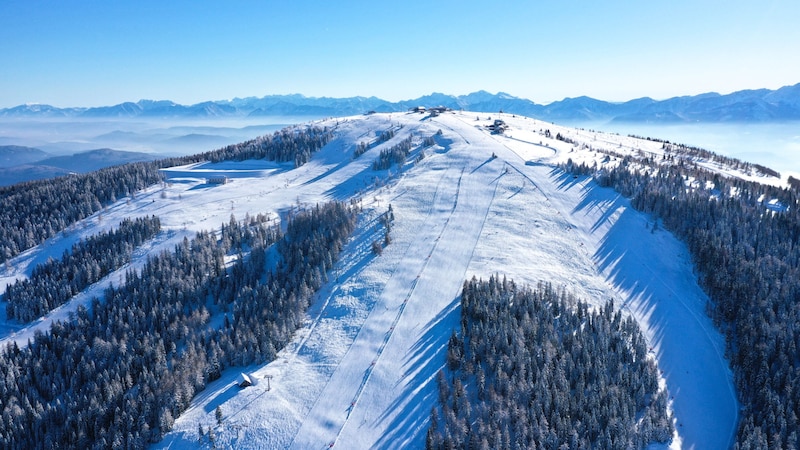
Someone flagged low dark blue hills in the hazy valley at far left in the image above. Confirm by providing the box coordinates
[0,145,158,186]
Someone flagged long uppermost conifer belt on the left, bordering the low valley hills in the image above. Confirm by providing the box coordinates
[0,127,333,263]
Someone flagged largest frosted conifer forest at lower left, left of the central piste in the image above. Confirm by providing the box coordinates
[0,203,355,449]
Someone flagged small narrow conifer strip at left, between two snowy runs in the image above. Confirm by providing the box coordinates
[5,216,161,322]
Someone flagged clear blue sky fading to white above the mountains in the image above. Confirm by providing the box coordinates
[0,0,800,108]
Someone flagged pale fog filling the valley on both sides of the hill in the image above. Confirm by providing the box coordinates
[0,116,800,177]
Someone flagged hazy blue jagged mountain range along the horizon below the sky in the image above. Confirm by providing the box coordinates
[0,83,800,123]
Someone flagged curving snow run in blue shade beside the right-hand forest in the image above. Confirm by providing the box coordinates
[558,175,738,448]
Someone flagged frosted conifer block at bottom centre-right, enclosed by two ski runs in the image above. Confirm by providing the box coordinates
[426,276,674,449]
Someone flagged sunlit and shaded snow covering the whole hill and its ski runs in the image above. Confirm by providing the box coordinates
[0,112,738,449]
